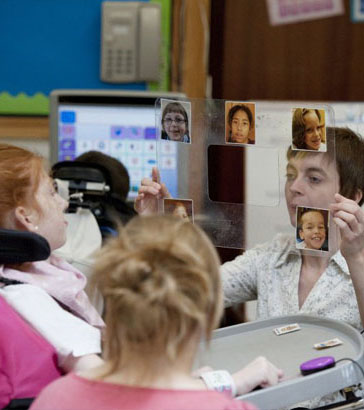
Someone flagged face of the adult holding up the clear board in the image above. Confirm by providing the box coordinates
[285,153,339,226]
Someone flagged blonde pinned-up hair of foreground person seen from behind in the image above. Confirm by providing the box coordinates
[93,215,222,373]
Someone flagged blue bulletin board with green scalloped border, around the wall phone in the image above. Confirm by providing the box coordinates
[0,0,171,115]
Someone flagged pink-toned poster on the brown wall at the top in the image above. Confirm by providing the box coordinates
[266,0,344,26]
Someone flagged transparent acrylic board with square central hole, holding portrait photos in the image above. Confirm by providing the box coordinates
[156,99,337,256]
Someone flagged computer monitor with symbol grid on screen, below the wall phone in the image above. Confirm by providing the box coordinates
[50,90,184,200]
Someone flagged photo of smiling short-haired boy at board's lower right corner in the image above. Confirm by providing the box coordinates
[296,207,329,252]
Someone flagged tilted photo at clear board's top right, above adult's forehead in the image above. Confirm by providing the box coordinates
[292,108,326,152]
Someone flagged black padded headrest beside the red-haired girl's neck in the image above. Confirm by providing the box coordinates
[0,229,51,265]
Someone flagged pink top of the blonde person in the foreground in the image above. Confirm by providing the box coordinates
[30,374,256,410]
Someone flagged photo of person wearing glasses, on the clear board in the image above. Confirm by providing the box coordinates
[161,99,191,144]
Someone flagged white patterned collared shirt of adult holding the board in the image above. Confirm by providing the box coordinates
[221,234,362,329]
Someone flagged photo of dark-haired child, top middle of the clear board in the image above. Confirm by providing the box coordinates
[225,101,255,144]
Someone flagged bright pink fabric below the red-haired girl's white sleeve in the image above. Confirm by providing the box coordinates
[0,297,62,409]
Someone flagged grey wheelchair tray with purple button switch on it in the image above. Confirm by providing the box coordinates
[195,315,364,410]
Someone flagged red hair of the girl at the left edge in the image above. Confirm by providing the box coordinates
[0,144,45,226]
